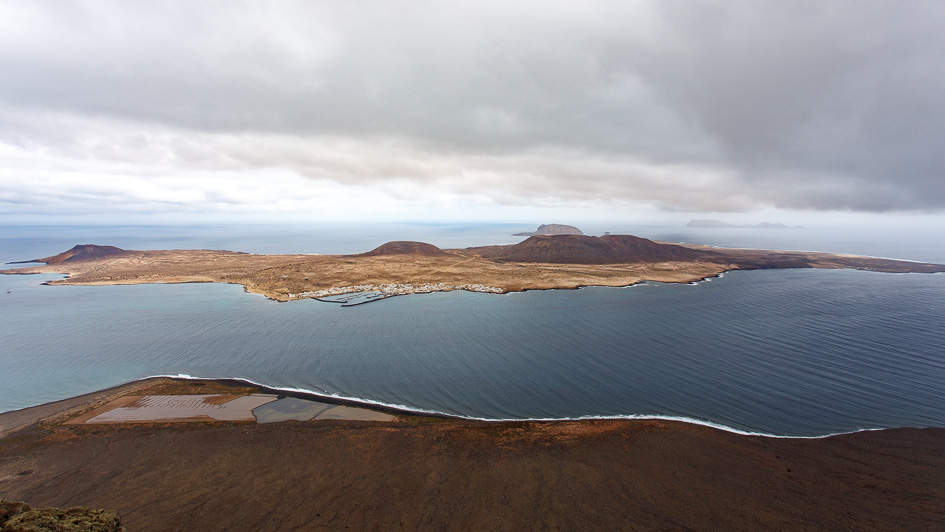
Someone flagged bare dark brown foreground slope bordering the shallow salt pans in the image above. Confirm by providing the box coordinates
[0,378,945,530]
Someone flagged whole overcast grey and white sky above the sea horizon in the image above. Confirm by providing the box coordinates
[0,0,945,223]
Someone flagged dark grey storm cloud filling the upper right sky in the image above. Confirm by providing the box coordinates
[640,2,945,210]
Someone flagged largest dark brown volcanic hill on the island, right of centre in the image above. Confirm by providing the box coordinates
[483,235,716,264]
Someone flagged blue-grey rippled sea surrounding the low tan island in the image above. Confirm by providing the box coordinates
[0,225,945,436]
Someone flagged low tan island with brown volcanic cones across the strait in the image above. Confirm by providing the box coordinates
[0,235,945,301]
